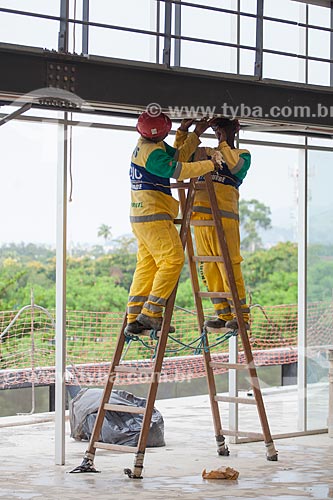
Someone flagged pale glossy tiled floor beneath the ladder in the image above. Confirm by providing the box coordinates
[0,391,333,500]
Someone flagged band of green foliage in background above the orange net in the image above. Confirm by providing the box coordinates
[0,236,333,312]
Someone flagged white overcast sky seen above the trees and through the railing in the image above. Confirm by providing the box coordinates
[0,0,331,245]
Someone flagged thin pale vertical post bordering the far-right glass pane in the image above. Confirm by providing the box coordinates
[297,145,308,431]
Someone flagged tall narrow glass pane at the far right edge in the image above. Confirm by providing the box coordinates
[306,151,333,430]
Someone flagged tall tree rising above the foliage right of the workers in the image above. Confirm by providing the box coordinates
[239,199,271,252]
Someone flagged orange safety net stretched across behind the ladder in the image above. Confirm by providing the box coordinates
[0,302,333,388]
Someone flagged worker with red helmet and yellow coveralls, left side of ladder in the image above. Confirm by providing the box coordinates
[125,112,220,334]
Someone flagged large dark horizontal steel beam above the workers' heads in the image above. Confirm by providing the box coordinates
[0,44,333,127]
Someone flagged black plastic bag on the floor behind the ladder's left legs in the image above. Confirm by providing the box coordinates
[69,389,165,447]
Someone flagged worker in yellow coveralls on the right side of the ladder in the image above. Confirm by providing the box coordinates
[174,118,251,330]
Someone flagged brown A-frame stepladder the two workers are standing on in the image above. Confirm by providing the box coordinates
[71,173,277,479]
